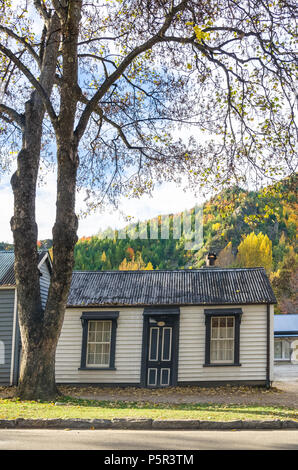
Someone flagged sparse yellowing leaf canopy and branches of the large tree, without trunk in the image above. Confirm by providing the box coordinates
[0,0,297,198]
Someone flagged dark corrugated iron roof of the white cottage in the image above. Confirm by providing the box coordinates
[68,268,276,307]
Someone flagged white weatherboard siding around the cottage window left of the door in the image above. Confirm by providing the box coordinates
[56,307,143,384]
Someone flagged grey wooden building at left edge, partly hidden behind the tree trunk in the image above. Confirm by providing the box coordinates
[0,251,51,386]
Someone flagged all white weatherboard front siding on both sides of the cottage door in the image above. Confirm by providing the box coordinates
[56,305,273,384]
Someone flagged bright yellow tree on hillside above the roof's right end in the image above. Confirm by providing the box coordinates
[237,232,272,273]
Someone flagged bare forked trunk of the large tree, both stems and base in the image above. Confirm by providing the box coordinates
[11,0,82,400]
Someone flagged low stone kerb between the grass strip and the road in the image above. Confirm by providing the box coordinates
[0,418,298,430]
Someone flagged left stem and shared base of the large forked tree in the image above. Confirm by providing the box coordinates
[11,14,60,399]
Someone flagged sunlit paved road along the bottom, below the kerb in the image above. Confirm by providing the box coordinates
[0,429,298,450]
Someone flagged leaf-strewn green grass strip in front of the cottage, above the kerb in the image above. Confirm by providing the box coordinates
[0,397,298,421]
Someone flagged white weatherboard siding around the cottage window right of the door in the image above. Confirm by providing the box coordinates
[178,305,273,382]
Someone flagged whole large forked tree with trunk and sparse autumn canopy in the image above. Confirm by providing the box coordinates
[0,0,297,399]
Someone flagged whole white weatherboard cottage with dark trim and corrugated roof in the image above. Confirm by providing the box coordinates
[56,267,276,387]
